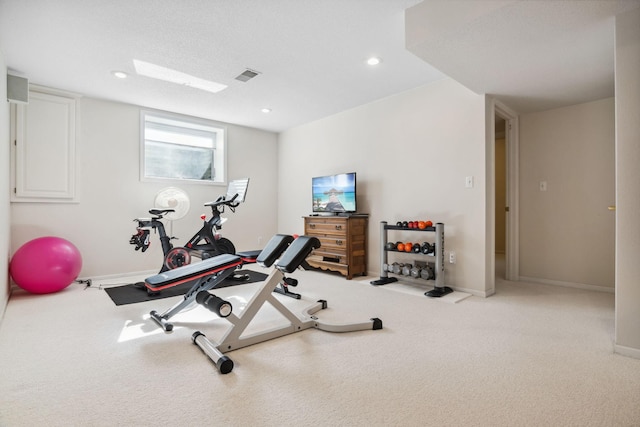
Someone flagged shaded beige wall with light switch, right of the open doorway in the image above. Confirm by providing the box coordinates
[520,98,615,291]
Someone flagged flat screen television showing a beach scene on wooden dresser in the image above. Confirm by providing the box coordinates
[311,172,356,214]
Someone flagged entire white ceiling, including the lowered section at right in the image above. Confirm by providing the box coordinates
[0,0,640,132]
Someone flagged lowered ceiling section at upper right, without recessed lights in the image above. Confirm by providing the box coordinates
[407,0,640,113]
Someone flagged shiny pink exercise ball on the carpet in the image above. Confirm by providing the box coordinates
[9,237,82,294]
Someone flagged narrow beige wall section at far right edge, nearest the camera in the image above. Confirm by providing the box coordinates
[615,8,640,359]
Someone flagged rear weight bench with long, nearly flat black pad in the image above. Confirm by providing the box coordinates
[149,234,293,331]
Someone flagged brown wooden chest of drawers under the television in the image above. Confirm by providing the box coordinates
[304,215,368,280]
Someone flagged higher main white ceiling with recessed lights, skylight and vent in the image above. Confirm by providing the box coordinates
[0,0,443,131]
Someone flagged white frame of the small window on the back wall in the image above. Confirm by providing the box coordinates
[140,110,227,186]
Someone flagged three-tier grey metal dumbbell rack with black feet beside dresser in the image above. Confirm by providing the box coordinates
[371,221,453,298]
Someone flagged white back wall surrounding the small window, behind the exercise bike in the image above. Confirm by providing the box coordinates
[3,98,278,277]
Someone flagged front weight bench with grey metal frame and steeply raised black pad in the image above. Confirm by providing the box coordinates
[191,236,382,374]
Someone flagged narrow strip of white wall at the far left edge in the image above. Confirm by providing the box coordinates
[0,52,11,321]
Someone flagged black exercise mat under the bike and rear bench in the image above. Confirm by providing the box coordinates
[105,270,267,305]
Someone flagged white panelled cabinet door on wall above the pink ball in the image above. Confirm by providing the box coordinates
[12,91,76,202]
